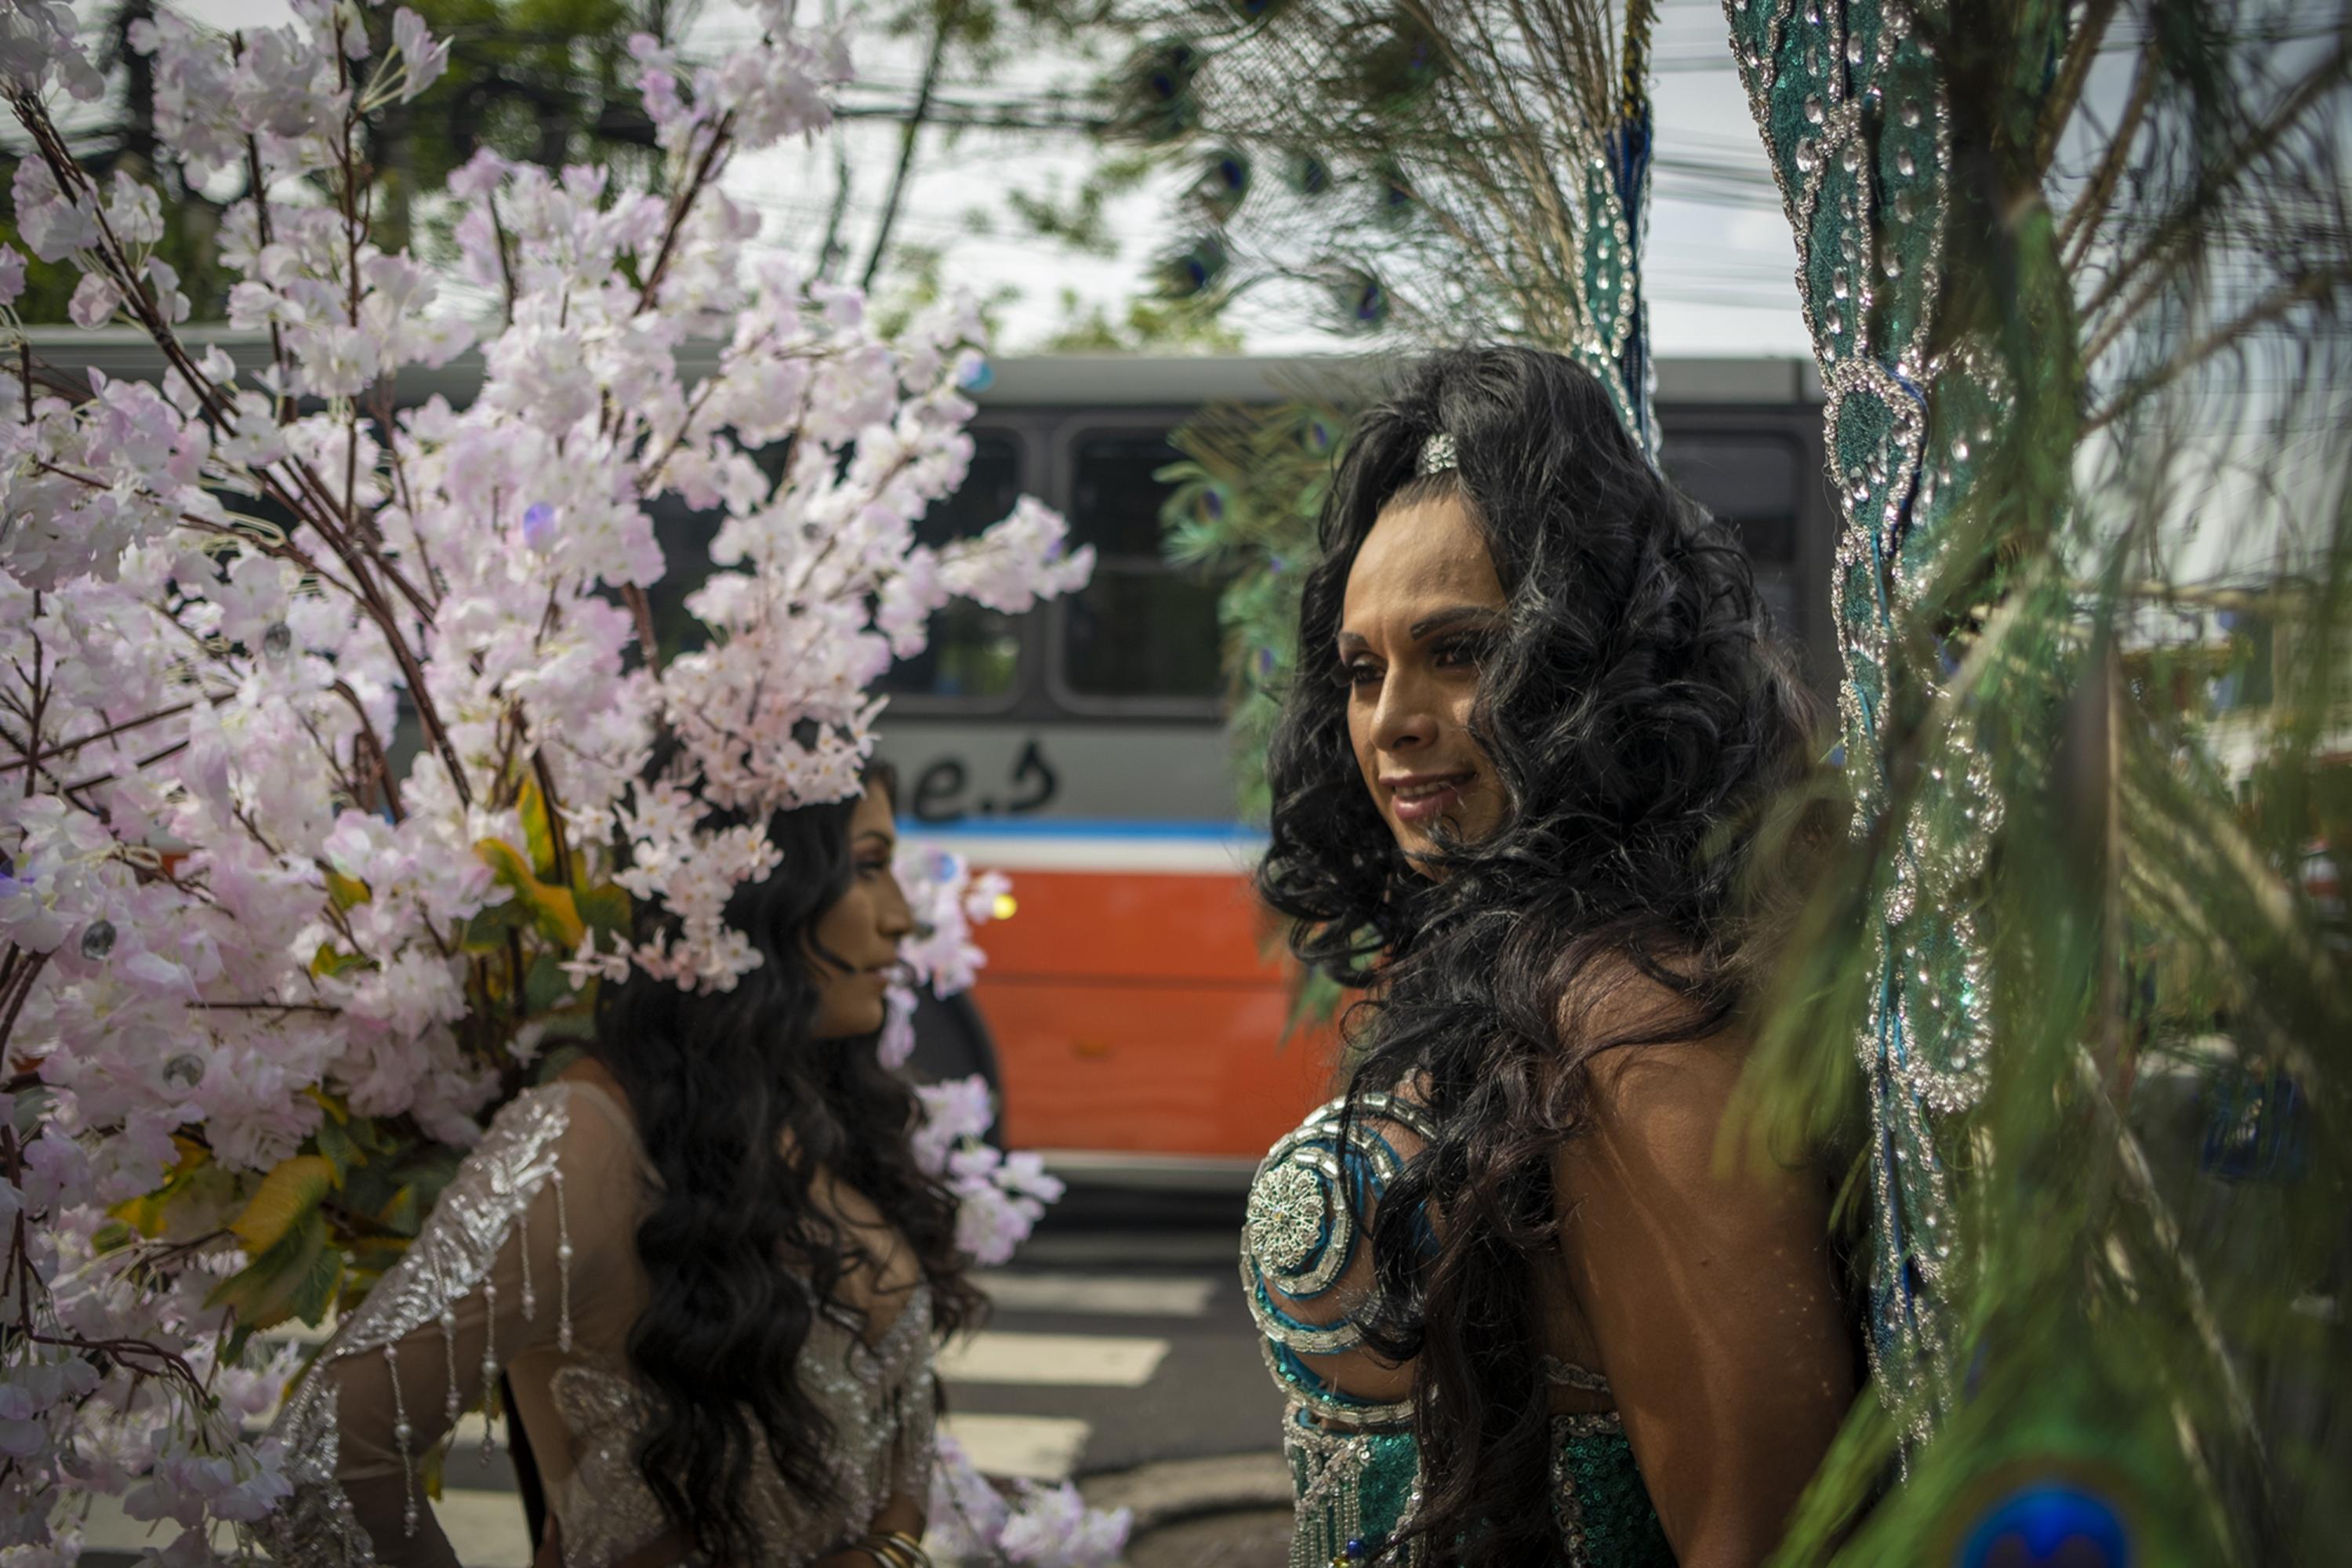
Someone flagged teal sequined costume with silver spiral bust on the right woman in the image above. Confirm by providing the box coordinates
[1242,1093,1675,1568]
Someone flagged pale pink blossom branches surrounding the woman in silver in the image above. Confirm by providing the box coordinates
[0,0,1110,1563]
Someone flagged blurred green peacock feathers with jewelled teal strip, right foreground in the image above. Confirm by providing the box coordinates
[1726,0,2352,1563]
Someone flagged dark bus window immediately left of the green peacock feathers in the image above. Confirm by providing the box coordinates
[1061,430,1218,706]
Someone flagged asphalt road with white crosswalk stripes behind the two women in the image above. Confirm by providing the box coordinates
[82,1187,1282,1568]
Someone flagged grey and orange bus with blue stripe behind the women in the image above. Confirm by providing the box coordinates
[856,355,1835,1185]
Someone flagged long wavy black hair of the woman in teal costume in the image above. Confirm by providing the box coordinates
[1258,348,1816,1563]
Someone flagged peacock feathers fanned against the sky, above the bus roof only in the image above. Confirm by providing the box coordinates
[1108,0,1656,447]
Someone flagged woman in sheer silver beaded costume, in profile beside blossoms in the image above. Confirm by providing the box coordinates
[263,771,978,1568]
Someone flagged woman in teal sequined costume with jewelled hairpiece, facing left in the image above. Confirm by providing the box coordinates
[1244,348,1856,1568]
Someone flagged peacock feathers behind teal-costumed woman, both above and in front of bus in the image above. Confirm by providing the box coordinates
[1143,0,1658,851]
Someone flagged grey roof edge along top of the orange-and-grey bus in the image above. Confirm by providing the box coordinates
[26,325,1820,409]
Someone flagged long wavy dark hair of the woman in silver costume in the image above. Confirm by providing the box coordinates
[590,760,981,1563]
